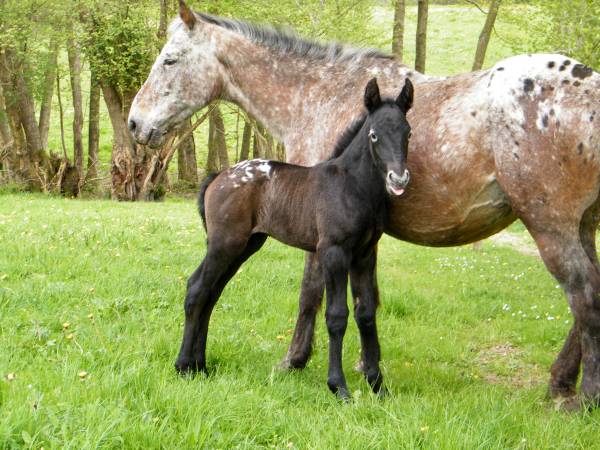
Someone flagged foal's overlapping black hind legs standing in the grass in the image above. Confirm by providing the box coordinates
[175,235,266,372]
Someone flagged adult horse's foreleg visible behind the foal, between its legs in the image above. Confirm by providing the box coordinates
[281,252,325,369]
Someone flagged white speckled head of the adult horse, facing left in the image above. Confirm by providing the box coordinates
[128,0,222,147]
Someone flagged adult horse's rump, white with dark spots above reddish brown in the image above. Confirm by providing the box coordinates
[489,54,600,226]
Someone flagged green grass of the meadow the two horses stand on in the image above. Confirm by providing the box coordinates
[0,194,600,449]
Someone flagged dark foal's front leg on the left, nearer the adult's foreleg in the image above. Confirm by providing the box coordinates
[317,245,350,400]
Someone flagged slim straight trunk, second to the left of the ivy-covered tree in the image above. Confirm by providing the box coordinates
[67,38,84,180]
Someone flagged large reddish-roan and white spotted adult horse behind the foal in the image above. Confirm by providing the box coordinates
[129,1,600,407]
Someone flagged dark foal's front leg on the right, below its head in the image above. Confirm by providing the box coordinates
[350,248,383,392]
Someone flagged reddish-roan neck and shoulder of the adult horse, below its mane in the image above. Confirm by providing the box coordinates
[222,34,421,165]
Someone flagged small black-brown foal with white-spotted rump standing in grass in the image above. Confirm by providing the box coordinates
[175,78,413,399]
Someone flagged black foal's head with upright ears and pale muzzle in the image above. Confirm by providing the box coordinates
[364,78,413,196]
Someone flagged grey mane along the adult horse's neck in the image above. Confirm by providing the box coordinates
[196,12,392,62]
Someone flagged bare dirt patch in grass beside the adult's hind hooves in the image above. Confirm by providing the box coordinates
[476,342,546,388]
